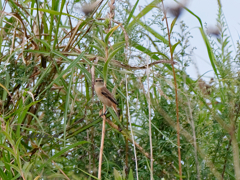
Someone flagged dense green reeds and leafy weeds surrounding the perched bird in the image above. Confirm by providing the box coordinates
[0,0,240,180]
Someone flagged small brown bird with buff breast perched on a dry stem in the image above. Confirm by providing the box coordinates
[94,78,118,115]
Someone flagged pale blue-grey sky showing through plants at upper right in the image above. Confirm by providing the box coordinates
[138,0,240,80]
